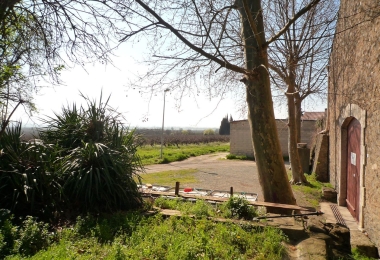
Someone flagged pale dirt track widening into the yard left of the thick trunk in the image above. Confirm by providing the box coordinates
[142,153,263,200]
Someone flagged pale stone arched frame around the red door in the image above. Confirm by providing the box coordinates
[337,104,367,229]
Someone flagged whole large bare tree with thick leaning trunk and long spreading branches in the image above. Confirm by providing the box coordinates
[121,0,319,212]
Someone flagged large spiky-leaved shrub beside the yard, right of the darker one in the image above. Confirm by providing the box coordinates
[40,95,142,212]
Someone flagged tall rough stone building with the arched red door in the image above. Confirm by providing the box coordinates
[328,0,380,250]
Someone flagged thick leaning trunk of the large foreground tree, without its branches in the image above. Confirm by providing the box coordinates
[235,0,296,213]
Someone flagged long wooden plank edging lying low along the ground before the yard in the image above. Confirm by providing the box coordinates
[143,191,315,211]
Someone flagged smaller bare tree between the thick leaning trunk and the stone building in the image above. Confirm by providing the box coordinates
[266,0,338,183]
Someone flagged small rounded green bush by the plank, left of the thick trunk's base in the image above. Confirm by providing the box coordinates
[223,196,257,220]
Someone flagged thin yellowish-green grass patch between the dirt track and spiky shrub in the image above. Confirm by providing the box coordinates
[141,169,198,186]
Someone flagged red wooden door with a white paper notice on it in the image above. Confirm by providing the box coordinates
[346,118,361,221]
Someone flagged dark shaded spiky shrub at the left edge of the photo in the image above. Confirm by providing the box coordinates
[0,123,63,218]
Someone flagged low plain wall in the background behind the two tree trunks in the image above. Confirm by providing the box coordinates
[230,119,316,156]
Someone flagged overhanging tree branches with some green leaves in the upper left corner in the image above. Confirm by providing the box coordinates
[0,0,124,132]
